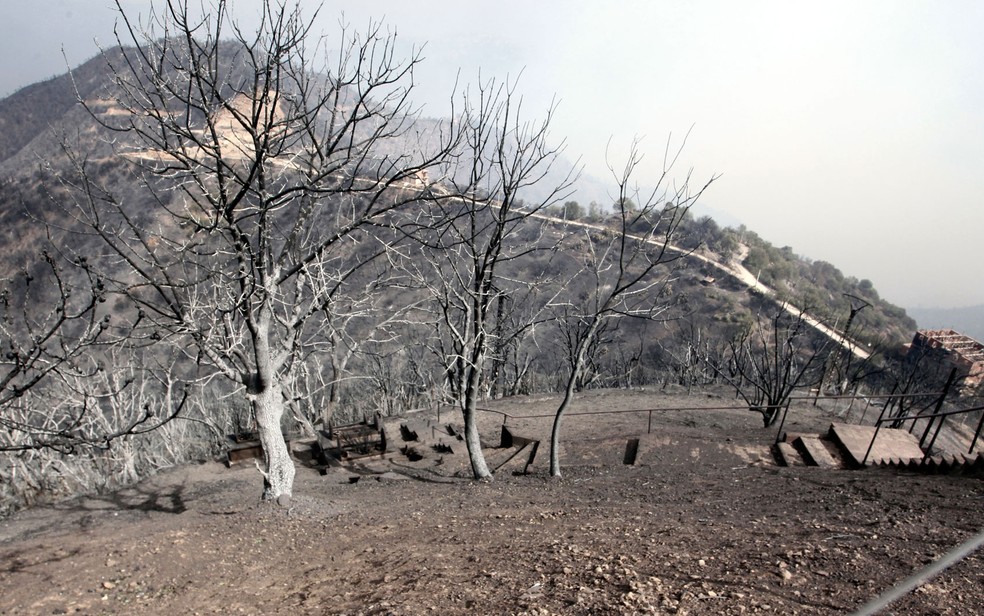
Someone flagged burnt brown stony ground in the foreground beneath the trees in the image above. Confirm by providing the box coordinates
[0,391,984,615]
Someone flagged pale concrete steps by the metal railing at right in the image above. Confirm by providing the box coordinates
[773,423,984,474]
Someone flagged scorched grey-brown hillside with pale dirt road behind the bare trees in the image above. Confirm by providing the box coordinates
[0,43,932,508]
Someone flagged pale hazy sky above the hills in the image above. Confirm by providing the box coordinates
[0,0,984,307]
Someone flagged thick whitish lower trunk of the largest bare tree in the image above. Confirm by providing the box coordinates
[253,384,294,504]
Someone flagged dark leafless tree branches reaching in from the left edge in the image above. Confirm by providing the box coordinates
[0,252,189,453]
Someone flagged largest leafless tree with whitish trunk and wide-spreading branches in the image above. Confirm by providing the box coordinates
[52,0,453,502]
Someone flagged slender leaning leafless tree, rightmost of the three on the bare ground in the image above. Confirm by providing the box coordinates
[550,138,713,477]
